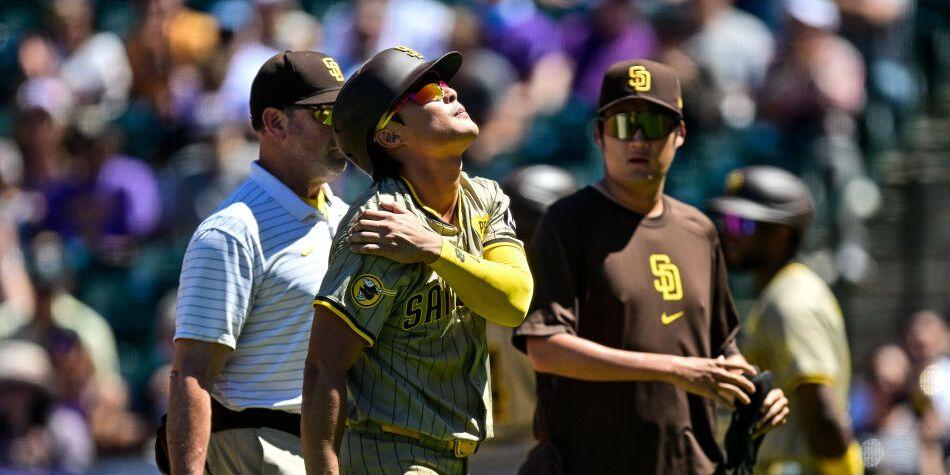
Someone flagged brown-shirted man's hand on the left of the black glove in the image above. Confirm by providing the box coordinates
[673,356,755,410]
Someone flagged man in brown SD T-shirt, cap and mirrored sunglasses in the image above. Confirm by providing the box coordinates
[514,60,788,474]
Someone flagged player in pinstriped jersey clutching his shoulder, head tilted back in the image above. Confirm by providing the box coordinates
[303,47,533,474]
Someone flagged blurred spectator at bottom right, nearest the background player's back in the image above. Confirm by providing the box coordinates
[854,345,944,475]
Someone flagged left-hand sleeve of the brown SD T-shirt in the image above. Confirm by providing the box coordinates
[512,205,582,351]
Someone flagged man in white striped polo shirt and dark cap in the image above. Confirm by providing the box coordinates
[166,51,347,474]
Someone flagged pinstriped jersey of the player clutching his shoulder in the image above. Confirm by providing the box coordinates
[314,173,520,458]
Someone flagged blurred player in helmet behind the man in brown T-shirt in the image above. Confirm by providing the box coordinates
[710,166,862,475]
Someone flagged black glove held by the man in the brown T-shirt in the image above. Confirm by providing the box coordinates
[726,371,772,475]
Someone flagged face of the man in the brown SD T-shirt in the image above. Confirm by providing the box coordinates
[597,100,685,185]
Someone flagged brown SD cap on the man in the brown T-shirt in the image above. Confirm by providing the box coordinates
[597,59,683,117]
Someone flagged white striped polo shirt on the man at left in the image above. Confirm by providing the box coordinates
[175,162,347,413]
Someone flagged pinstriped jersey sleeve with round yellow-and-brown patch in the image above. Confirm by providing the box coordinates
[314,240,421,346]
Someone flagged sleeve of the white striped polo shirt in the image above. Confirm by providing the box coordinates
[175,229,254,349]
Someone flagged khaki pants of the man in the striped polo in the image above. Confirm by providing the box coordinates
[205,428,306,475]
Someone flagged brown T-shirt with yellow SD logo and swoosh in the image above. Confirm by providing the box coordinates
[514,187,738,474]
